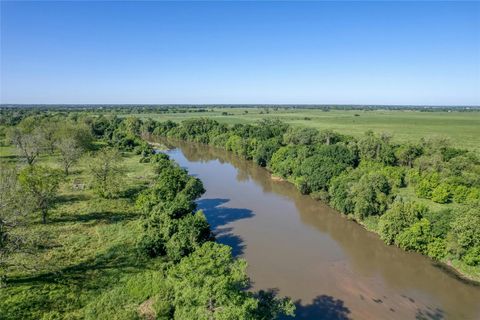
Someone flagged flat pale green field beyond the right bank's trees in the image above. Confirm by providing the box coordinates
[124,108,480,151]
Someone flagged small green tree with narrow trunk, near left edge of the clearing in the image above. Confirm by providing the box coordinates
[19,165,62,224]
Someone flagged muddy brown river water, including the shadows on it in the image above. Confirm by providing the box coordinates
[163,142,480,319]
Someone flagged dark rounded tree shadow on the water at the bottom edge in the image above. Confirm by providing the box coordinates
[280,295,350,320]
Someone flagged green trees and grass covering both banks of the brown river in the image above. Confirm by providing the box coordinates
[0,108,480,319]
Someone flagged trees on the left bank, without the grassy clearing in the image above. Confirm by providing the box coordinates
[0,114,295,319]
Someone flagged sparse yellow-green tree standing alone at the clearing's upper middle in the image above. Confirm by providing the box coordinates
[88,148,124,198]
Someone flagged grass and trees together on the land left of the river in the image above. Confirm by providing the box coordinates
[0,117,294,320]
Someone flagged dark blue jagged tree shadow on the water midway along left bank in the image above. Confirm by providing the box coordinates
[197,198,254,256]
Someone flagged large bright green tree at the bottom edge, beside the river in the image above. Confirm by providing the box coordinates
[163,242,295,320]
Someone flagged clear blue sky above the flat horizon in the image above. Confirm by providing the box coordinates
[0,1,480,105]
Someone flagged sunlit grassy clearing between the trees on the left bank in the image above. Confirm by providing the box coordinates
[0,148,163,319]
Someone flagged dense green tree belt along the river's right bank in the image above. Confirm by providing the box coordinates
[146,119,480,267]
